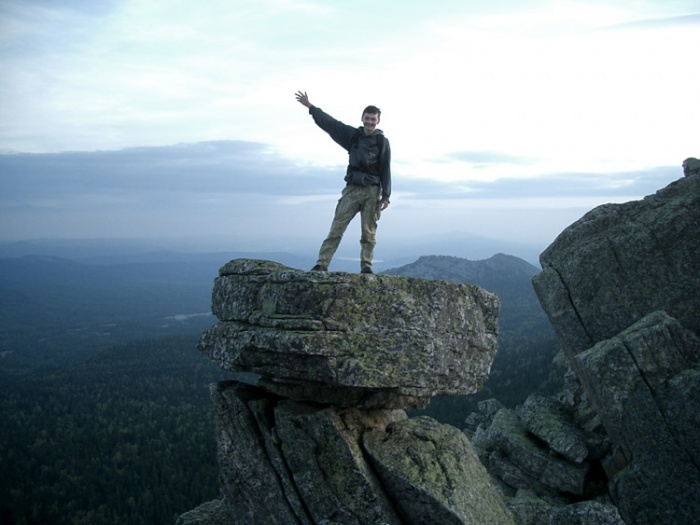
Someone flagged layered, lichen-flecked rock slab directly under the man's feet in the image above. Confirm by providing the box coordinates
[199,259,499,408]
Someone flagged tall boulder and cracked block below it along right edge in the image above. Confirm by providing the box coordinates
[533,174,700,525]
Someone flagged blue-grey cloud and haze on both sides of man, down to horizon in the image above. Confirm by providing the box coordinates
[0,141,681,246]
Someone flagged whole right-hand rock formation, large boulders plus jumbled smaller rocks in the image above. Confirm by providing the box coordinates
[465,173,700,525]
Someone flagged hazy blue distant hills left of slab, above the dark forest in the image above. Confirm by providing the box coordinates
[0,255,217,373]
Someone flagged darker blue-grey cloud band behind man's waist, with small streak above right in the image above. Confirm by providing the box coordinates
[0,141,682,212]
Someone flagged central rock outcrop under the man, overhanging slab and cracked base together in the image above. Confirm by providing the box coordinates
[180,260,514,525]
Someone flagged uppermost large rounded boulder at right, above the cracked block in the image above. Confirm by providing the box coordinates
[533,175,700,358]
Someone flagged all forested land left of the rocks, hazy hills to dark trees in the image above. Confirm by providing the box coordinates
[0,255,227,525]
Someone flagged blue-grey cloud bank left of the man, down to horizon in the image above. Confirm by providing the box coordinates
[0,141,343,239]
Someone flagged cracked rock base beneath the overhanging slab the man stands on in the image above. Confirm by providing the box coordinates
[204,382,513,525]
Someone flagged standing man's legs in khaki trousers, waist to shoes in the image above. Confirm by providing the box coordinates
[316,185,381,269]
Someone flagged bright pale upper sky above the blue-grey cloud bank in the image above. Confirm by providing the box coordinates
[0,0,697,173]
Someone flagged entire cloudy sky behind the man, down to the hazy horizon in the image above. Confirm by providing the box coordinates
[0,0,700,266]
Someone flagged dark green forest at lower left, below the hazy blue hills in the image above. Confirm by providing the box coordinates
[0,335,226,525]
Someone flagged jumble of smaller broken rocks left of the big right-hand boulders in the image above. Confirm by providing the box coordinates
[465,364,624,525]
